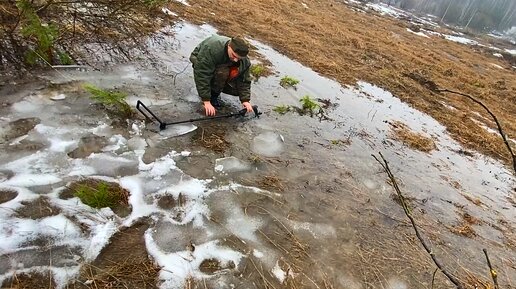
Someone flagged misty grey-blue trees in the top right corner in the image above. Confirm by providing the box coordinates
[367,0,516,39]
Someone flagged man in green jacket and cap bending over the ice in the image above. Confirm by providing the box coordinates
[190,35,253,116]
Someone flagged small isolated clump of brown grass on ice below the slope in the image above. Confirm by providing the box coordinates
[389,121,436,153]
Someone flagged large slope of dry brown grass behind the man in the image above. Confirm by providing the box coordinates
[170,0,516,163]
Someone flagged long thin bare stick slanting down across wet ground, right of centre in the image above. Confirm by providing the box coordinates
[372,153,464,289]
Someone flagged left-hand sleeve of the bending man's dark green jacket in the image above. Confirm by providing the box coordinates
[195,46,215,101]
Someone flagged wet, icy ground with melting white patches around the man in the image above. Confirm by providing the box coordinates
[0,23,516,289]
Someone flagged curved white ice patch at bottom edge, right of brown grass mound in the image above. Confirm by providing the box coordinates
[145,229,244,289]
